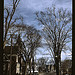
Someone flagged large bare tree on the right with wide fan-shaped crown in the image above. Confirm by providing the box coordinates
[36,6,72,75]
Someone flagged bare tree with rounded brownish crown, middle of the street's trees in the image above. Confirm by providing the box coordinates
[25,26,41,74]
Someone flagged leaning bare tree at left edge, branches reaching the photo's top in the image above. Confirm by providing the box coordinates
[3,0,23,48]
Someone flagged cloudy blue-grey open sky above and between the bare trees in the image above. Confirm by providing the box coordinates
[4,0,72,60]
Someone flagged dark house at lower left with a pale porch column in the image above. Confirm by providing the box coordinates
[3,46,23,75]
